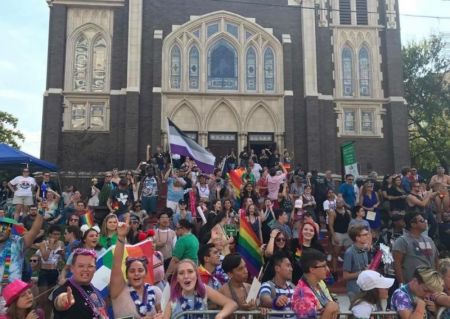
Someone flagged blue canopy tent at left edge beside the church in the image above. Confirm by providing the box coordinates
[0,143,58,171]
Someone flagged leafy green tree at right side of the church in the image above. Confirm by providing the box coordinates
[402,36,450,172]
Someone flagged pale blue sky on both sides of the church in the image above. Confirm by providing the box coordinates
[0,0,450,157]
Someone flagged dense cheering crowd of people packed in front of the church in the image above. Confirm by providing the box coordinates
[0,146,450,319]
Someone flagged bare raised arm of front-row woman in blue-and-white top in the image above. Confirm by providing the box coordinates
[109,218,130,299]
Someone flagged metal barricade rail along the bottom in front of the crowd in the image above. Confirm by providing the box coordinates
[173,310,398,319]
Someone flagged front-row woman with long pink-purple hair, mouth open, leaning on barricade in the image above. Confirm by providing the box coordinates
[163,259,237,319]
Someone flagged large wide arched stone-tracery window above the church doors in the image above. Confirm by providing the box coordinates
[162,11,283,94]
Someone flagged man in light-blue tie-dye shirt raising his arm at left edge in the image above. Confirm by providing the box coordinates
[0,215,43,313]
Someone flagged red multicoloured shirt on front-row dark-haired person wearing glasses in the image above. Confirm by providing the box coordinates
[292,279,333,319]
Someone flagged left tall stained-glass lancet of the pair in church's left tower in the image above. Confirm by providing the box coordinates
[72,34,89,92]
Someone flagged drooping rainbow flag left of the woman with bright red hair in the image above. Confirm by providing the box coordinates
[237,213,263,277]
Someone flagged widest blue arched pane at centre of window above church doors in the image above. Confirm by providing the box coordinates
[208,39,238,90]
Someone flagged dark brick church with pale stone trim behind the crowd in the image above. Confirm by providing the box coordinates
[41,0,410,174]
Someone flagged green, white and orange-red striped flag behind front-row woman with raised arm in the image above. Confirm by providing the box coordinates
[92,239,153,298]
